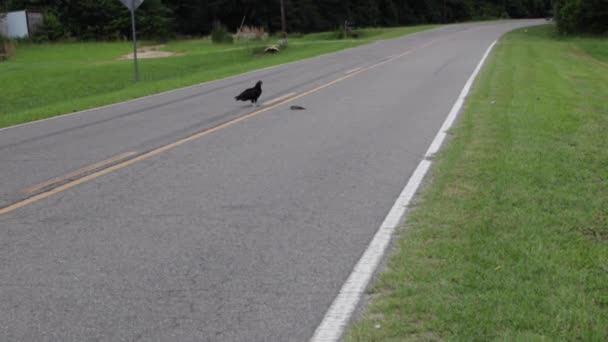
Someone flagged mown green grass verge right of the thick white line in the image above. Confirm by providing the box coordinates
[345,26,608,341]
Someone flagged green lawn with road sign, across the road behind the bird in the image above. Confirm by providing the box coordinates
[0,26,433,127]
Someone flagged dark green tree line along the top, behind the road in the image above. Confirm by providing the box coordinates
[0,0,608,40]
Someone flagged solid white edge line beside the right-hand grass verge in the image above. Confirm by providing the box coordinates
[310,40,496,342]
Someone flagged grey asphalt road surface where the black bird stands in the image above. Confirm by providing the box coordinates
[0,21,542,341]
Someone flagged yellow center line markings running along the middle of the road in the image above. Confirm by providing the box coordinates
[0,35,452,215]
